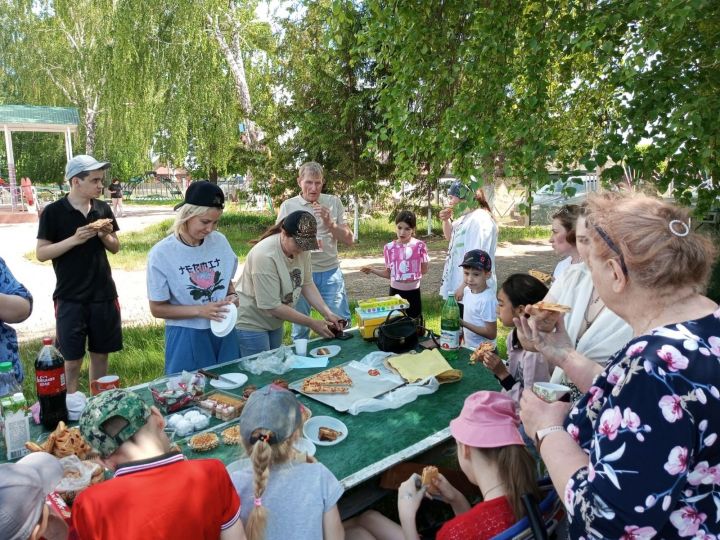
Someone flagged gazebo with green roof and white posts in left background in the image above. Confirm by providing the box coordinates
[0,105,79,212]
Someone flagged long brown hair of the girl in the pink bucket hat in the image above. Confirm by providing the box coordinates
[478,444,540,520]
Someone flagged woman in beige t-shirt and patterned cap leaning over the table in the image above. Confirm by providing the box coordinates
[236,210,342,357]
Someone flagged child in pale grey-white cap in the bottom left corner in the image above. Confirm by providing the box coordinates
[0,452,67,540]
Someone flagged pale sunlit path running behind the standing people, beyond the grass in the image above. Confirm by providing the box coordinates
[0,206,556,341]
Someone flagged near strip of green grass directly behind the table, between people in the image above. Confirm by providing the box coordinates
[20,295,509,403]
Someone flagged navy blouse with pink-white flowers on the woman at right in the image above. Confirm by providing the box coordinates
[564,310,720,539]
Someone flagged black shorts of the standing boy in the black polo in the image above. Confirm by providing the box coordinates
[55,298,122,360]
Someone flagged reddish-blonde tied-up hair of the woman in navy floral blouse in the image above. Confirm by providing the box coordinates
[585,194,716,291]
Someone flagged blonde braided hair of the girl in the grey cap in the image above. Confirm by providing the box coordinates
[243,428,299,540]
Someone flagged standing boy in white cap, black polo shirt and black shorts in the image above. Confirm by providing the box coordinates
[35,155,122,394]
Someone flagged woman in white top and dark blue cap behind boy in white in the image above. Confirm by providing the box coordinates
[440,181,498,316]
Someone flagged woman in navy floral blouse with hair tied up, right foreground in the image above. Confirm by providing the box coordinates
[517,196,720,538]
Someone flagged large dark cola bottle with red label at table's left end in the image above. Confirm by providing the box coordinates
[35,338,68,430]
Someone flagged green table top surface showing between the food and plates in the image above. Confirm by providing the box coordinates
[21,331,500,489]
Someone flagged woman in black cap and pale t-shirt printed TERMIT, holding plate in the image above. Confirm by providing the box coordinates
[147,181,238,373]
